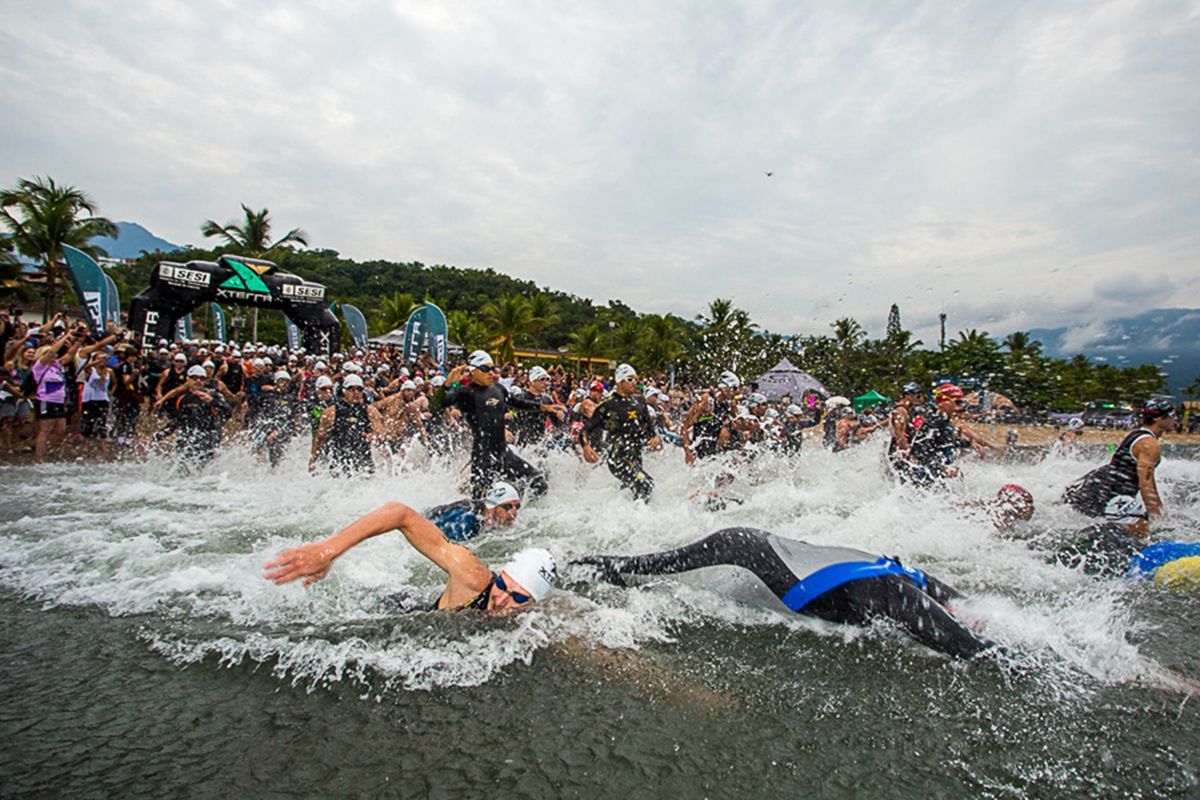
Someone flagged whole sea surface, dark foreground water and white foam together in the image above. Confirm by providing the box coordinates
[0,441,1200,798]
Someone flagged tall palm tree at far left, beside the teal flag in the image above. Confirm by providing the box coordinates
[0,176,119,319]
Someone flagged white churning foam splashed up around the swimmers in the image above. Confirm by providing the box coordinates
[0,439,1200,688]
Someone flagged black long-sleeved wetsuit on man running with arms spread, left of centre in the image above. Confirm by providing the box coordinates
[430,381,550,499]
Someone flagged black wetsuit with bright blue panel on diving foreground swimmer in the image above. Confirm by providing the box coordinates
[572,528,995,658]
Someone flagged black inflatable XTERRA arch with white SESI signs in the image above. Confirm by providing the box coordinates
[130,255,338,356]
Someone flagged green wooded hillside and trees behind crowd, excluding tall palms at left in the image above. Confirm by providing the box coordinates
[113,239,1171,410]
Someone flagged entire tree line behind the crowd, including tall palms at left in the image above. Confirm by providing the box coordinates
[0,178,1180,411]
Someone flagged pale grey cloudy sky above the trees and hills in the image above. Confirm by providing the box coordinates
[0,0,1200,344]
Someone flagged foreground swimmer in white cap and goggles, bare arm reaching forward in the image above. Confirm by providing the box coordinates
[263,503,556,613]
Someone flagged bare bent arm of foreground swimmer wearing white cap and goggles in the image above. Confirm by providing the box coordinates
[263,503,492,600]
